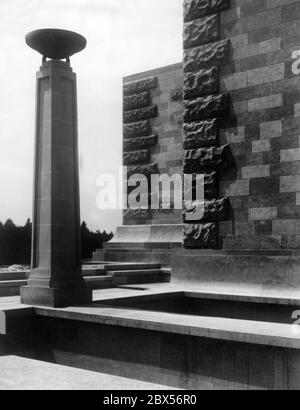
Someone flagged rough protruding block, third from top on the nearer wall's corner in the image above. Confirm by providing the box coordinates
[183,40,230,73]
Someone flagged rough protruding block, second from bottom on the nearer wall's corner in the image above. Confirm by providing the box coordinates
[183,198,229,223]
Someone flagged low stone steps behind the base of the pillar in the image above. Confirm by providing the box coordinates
[0,262,171,297]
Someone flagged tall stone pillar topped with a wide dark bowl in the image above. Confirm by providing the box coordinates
[21,30,92,307]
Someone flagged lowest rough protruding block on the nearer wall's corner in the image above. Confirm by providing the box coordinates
[183,223,218,249]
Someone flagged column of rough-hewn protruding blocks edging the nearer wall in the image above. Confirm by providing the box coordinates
[183,0,234,249]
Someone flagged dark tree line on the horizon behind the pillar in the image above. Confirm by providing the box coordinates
[0,219,113,265]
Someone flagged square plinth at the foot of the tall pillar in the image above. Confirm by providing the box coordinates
[21,286,93,308]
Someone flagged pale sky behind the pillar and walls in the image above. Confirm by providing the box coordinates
[0,0,182,231]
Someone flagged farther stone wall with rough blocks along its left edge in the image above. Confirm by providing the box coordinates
[123,63,183,225]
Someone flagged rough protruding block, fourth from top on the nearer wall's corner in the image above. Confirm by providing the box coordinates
[183,67,220,100]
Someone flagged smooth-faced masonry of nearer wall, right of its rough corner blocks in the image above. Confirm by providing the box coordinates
[220,0,300,249]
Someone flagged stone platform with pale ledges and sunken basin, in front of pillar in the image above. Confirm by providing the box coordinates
[0,283,300,390]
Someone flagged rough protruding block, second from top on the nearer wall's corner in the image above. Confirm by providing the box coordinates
[183,14,220,49]
